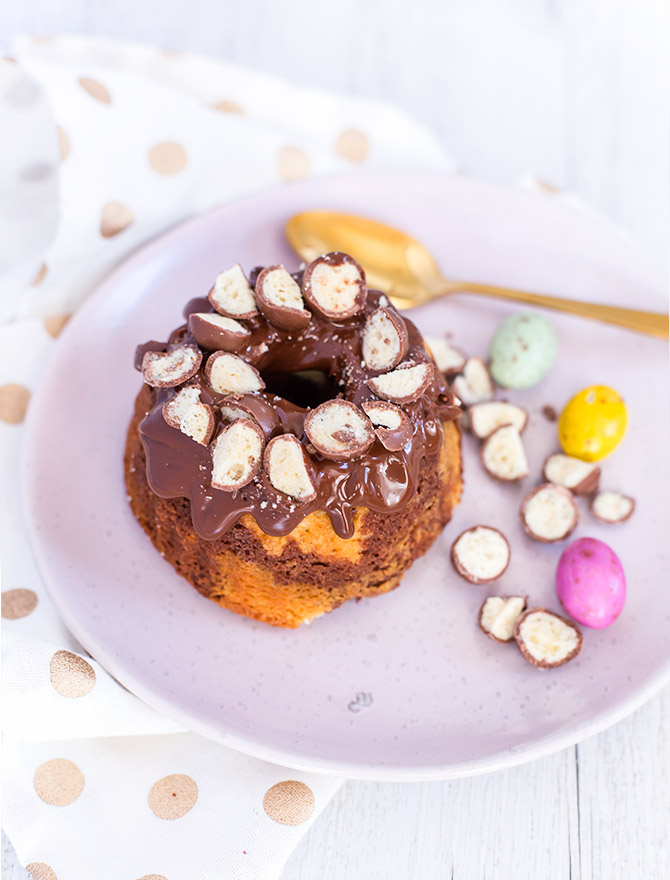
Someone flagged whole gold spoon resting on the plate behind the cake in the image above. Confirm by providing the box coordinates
[286,211,668,339]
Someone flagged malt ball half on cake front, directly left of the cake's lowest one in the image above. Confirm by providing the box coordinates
[211,419,265,492]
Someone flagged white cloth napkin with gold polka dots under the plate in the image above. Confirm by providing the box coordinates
[0,37,450,880]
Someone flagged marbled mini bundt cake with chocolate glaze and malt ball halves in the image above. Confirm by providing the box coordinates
[125,253,461,627]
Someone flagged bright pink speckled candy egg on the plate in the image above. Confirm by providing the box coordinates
[556,538,626,629]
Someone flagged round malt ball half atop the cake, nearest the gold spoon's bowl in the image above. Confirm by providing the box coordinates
[302,251,367,321]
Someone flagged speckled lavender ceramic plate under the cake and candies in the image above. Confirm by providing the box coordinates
[25,174,670,779]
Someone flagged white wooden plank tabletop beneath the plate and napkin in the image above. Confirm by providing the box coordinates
[0,0,670,880]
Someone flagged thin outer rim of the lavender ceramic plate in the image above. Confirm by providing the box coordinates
[20,170,670,782]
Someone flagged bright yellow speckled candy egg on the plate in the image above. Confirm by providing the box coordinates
[558,385,628,461]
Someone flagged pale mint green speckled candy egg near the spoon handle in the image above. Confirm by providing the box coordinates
[489,312,558,388]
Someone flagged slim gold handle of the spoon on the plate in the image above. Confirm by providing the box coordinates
[444,281,668,339]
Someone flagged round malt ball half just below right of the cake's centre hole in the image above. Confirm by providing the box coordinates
[305,400,375,461]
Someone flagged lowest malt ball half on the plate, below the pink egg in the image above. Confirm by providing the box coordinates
[514,608,582,669]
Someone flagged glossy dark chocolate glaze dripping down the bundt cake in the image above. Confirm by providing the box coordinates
[135,271,460,540]
